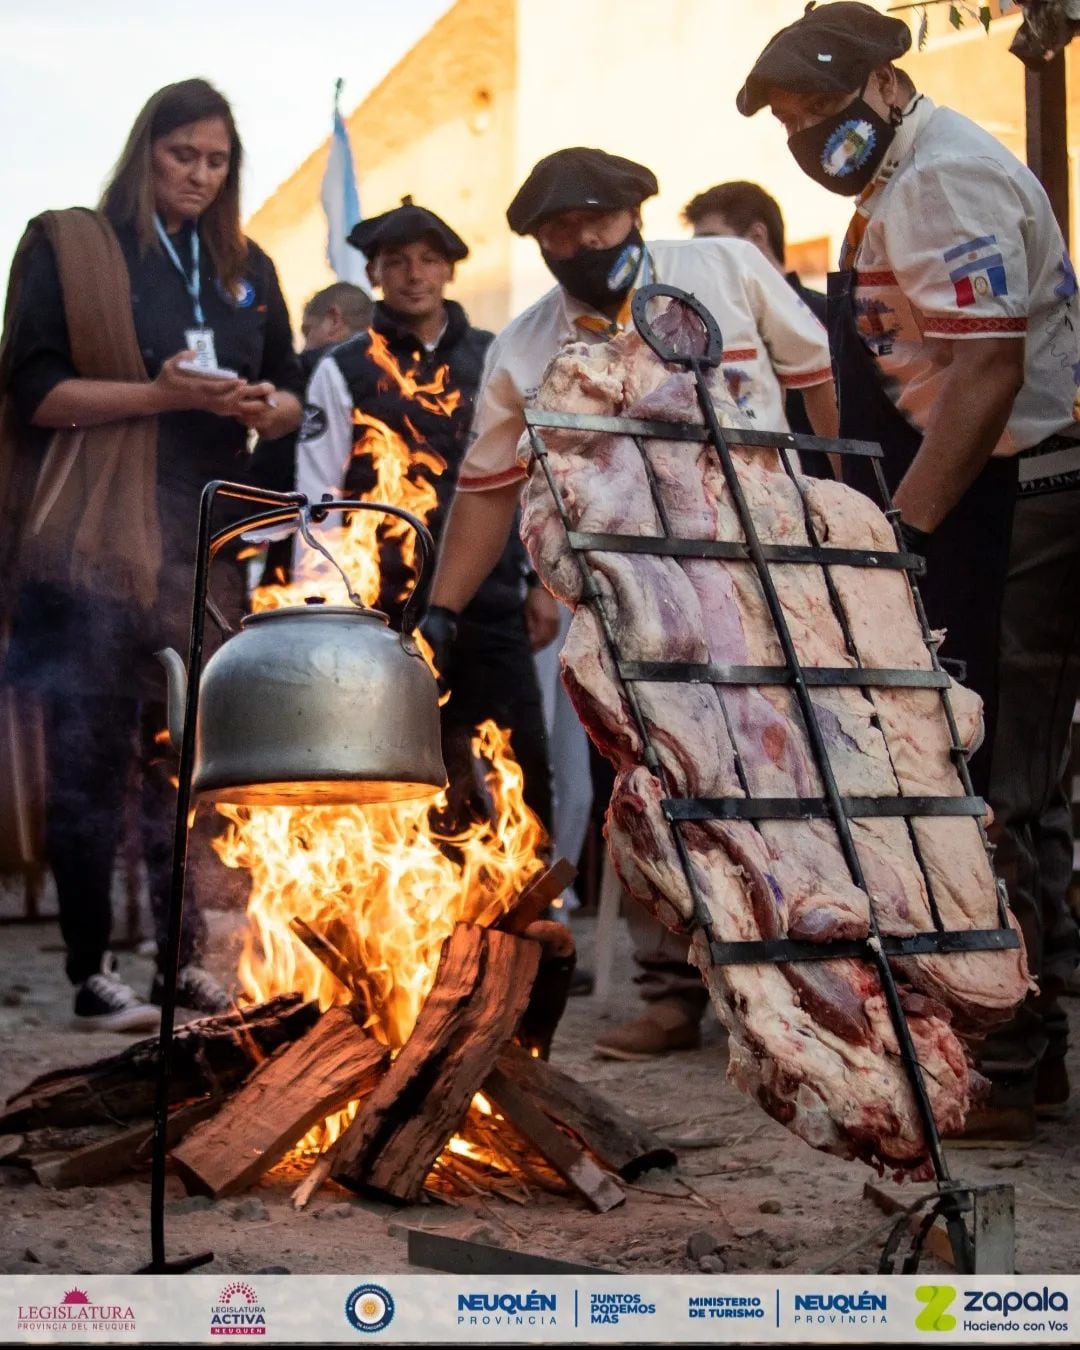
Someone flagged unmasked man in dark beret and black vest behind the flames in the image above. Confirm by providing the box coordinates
[296,197,559,829]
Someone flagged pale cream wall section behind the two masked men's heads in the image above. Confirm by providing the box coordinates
[510,0,851,308]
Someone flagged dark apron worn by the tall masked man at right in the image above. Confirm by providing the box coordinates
[829,270,1017,797]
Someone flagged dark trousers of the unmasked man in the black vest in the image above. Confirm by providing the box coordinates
[443,610,552,834]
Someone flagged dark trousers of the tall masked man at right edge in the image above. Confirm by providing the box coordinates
[980,487,1080,1073]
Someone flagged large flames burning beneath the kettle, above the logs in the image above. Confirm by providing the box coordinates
[215,721,544,1143]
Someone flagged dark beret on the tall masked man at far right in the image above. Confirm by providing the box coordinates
[736,0,911,117]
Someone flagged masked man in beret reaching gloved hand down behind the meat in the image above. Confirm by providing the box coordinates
[424,147,836,1060]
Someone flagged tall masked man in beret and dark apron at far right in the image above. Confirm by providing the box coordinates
[737,0,1080,1142]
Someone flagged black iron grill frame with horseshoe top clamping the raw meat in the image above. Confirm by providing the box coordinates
[525,285,1019,1273]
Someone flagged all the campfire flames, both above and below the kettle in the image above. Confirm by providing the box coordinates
[215,333,544,1157]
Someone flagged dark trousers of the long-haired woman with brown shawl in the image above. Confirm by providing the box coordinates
[42,693,203,984]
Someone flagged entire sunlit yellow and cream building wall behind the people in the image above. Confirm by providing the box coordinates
[248,0,1080,337]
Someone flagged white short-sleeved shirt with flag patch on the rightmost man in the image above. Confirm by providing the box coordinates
[855,96,1080,456]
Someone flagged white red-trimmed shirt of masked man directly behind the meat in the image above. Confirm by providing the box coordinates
[458,239,833,493]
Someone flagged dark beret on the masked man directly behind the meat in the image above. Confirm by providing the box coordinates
[506,146,660,235]
